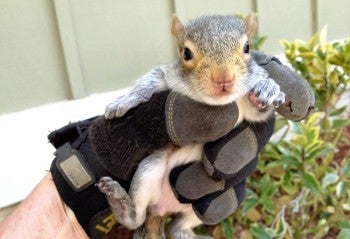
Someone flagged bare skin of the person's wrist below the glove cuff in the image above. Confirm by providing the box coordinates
[0,173,89,239]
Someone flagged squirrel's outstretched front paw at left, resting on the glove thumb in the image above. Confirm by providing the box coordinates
[105,94,146,119]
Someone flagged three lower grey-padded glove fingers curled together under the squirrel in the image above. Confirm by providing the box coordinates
[170,117,275,224]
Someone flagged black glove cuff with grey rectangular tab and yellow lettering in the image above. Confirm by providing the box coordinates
[49,119,129,239]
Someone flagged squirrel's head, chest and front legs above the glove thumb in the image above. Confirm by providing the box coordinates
[105,14,284,121]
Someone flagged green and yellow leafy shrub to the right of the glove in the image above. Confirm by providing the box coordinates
[201,28,350,239]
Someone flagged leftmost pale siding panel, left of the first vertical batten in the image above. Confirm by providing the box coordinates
[0,0,70,113]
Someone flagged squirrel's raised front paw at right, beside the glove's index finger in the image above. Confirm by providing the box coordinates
[250,78,285,108]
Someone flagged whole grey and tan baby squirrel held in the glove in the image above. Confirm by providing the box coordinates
[98,14,285,238]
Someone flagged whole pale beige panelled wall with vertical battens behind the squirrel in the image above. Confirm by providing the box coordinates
[0,0,350,113]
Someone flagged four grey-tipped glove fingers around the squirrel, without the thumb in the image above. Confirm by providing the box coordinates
[170,51,315,224]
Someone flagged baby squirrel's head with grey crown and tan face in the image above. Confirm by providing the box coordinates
[171,14,257,104]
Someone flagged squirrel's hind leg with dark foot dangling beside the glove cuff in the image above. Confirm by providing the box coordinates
[97,147,172,229]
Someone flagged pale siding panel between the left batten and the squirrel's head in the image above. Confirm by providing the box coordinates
[71,0,175,94]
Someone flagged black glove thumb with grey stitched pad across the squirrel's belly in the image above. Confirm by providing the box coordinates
[89,91,238,180]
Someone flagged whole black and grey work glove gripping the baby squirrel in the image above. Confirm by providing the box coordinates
[50,50,314,235]
